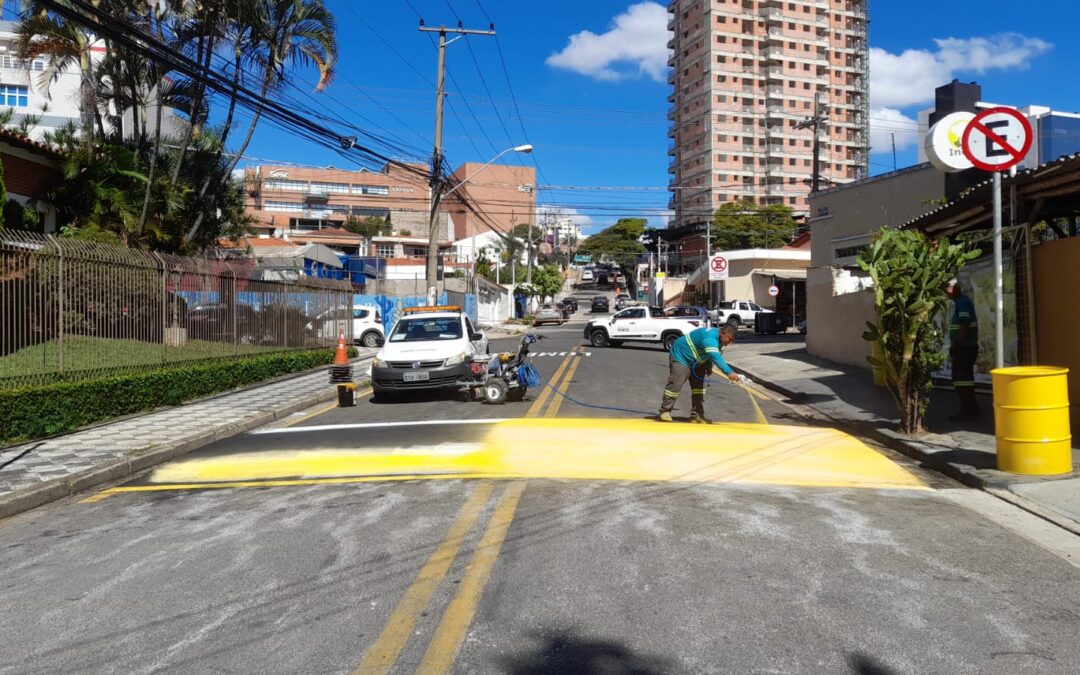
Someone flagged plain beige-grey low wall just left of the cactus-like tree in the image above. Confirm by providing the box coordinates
[807,268,875,368]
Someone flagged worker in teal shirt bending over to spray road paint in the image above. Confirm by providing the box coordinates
[660,324,739,424]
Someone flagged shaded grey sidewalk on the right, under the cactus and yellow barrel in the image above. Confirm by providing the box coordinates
[731,334,1080,534]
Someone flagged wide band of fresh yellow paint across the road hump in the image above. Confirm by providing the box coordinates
[139,418,924,489]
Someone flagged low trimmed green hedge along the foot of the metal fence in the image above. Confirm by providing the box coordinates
[0,350,354,444]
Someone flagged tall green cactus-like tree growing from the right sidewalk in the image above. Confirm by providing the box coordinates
[859,229,978,434]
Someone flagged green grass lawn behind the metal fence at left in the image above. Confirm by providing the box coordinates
[0,337,282,388]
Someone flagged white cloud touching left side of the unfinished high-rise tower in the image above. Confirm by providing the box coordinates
[546,2,671,82]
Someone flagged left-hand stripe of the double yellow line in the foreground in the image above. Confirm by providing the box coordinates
[354,483,492,674]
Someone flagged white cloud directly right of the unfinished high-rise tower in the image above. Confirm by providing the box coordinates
[870,32,1053,152]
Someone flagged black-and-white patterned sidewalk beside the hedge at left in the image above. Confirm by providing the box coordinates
[0,349,376,518]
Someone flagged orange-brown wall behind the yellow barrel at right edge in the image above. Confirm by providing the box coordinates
[1031,237,1080,405]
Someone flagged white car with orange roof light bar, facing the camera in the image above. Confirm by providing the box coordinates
[372,307,487,399]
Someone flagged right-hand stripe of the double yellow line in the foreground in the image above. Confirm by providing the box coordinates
[417,482,525,673]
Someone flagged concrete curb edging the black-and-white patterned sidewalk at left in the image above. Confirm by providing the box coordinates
[0,359,367,519]
